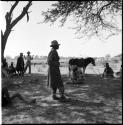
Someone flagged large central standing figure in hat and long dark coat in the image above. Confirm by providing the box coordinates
[47,40,65,100]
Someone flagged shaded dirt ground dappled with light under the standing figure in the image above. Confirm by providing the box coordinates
[2,73,122,124]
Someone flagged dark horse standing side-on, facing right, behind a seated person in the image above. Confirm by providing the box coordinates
[69,57,95,77]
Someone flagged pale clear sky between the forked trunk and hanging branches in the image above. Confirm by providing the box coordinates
[0,1,122,57]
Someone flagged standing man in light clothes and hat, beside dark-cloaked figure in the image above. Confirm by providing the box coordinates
[24,51,33,74]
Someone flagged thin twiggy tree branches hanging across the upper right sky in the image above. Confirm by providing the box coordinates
[42,0,122,38]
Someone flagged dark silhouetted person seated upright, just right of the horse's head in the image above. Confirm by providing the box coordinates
[103,63,114,78]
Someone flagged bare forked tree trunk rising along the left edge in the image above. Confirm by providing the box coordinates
[1,1,32,59]
